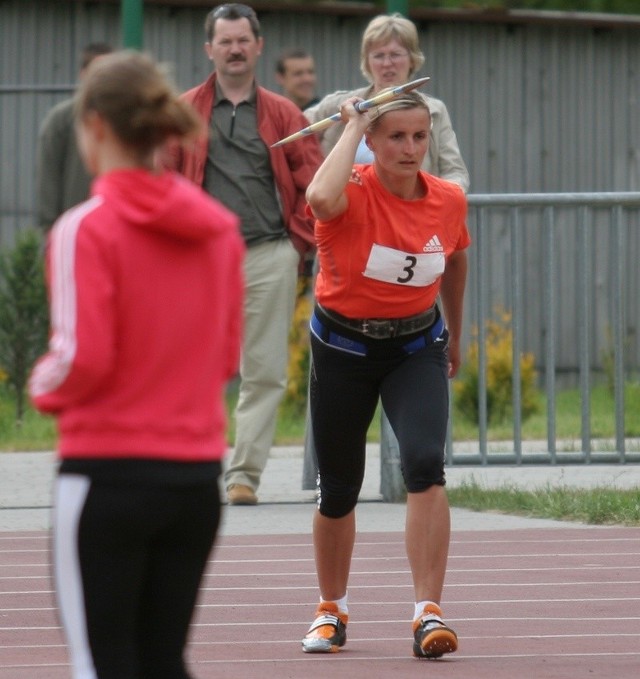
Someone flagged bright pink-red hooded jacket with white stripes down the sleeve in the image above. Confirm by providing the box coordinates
[29,169,244,462]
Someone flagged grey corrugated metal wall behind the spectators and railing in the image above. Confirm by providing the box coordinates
[0,0,640,374]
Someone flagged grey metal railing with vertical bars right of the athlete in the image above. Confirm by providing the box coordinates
[446,192,640,464]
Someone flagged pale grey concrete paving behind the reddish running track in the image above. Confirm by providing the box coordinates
[0,444,640,535]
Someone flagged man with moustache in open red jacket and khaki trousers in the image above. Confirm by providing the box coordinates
[173,3,322,505]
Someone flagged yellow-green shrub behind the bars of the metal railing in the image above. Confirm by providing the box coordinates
[453,312,540,424]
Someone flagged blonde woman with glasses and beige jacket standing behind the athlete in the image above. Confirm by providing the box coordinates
[304,13,469,192]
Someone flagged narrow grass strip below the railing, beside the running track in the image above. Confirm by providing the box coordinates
[447,481,640,526]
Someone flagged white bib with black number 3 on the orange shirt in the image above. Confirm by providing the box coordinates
[364,243,444,288]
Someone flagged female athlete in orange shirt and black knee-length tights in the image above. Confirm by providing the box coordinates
[302,94,470,658]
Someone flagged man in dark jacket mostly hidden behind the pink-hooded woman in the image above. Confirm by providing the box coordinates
[36,42,113,231]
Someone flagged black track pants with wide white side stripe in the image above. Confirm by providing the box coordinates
[53,474,220,679]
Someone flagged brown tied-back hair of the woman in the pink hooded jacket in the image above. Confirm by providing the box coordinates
[76,50,202,154]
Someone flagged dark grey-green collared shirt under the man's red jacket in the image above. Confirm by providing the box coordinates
[203,83,287,246]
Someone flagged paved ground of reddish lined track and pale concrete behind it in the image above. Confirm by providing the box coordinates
[0,447,640,679]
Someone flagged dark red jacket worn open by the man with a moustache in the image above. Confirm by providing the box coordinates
[168,71,323,255]
